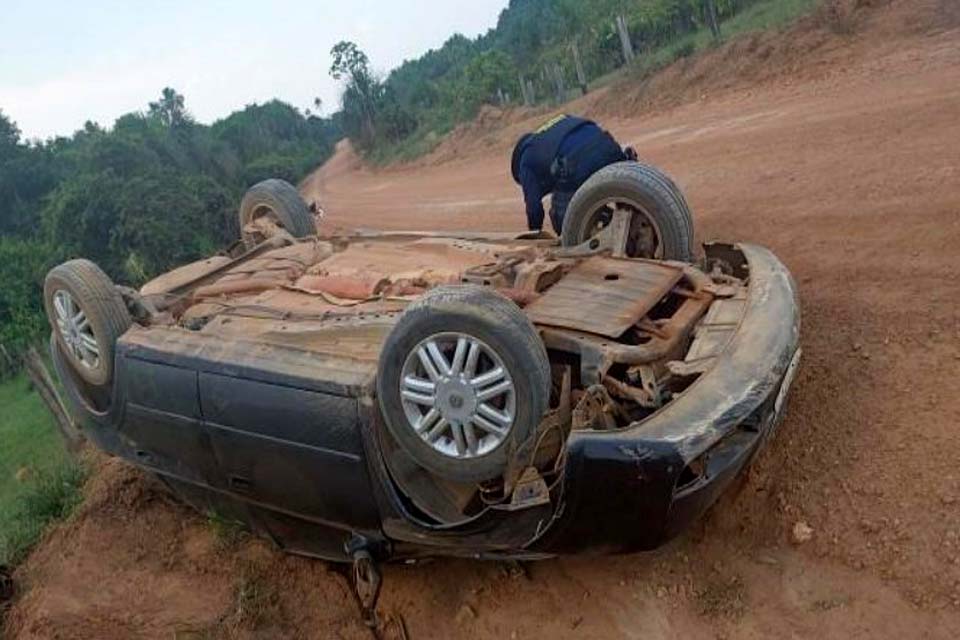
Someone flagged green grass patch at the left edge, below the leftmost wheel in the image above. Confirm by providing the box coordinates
[0,374,85,565]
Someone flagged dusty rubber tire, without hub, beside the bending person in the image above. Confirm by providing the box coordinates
[560,161,696,262]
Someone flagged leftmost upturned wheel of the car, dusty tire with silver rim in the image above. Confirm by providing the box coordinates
[43,259,133,387]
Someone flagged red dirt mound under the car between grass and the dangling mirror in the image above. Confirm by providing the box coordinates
[6,457,369,639]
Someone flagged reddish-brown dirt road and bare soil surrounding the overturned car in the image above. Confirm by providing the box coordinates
[7,0,960,640]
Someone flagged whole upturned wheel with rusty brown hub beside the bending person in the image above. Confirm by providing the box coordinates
[561,162,696,262]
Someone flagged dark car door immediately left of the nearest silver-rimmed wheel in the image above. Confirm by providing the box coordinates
[199,372,379,529]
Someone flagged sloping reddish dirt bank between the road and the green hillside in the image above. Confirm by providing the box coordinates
[400,0,940,167]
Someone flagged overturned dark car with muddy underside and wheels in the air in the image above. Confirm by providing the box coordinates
[44,163,800,566]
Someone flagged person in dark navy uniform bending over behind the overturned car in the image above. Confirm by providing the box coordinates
[511,115,628,234]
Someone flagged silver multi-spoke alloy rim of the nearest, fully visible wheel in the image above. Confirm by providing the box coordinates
[399,332,516,459]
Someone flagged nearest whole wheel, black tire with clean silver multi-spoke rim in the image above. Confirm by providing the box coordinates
[377,286,550,482]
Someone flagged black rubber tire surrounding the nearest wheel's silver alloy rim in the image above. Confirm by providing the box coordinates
[377,285,550,482]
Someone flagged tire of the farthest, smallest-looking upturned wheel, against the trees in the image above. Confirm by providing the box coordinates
[240,178,317,248]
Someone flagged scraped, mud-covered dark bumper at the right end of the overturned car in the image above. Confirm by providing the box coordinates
[536,245,800,553]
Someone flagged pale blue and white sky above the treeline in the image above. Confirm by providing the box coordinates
[0,0,507,139]
